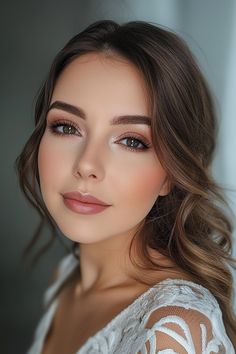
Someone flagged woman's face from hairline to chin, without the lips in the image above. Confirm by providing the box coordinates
[38,53,167,243]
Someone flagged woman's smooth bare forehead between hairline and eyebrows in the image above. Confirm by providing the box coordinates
[52,53,149,113]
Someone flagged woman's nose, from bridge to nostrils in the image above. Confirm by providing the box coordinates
[73,137,105,181]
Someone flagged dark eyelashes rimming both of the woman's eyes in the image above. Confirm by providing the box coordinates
[49,121,151,152]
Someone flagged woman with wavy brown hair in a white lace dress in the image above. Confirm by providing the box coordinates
[17,21,236,354]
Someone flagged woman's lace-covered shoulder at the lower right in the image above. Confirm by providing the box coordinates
[136,280,235,354]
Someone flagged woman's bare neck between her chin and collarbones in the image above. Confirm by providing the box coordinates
[75,228,138,293]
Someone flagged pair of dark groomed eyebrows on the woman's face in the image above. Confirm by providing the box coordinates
[48,101,151,126]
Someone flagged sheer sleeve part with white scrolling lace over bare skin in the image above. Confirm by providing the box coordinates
[138,306,230,354]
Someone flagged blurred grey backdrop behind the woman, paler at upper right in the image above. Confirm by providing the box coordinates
[0,0,236,354]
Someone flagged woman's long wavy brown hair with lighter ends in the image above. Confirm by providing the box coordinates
[16,20,236,345]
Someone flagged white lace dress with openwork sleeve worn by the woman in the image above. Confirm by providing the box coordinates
[27,254,235,354]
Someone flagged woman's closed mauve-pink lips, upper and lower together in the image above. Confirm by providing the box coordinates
[63,192,110,214]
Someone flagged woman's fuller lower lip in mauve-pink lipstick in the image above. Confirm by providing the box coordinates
[63,198,109,215]
